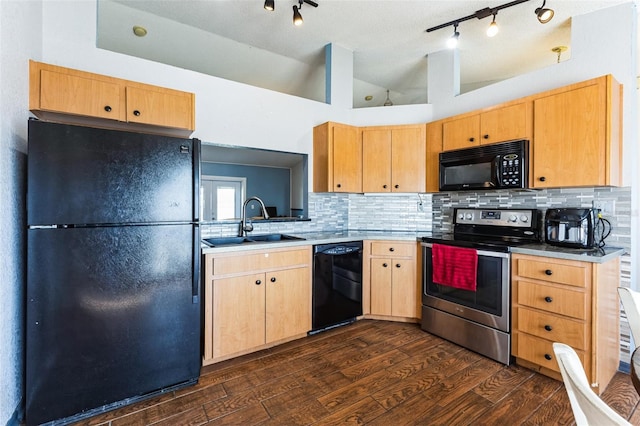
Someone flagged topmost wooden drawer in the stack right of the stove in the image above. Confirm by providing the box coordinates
[515,259,591,287]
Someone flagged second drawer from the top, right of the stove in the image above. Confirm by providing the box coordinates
[516,280,587,320]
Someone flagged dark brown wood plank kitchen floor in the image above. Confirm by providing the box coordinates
[72,320,640,426]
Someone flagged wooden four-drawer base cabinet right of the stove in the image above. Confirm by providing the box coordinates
[511,254,620,393]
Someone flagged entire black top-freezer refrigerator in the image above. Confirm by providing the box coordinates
[25,120,201,425]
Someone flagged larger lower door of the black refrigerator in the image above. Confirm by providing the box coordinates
[26,225,201,424]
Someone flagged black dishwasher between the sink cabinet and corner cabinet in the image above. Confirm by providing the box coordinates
[310,241,362,334]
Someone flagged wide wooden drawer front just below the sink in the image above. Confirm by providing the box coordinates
[213,250,311,275]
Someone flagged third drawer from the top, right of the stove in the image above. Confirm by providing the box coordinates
[518,308,587,350]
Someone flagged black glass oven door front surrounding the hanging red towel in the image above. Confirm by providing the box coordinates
[423,247,509,316]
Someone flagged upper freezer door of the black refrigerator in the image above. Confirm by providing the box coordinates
[27,120,200,226]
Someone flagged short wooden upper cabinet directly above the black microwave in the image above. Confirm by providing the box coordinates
[442,101,531,151]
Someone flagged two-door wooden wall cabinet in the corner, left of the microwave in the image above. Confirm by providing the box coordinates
[362,124,426,192]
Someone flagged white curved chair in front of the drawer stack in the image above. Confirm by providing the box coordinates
[553,343,631,426]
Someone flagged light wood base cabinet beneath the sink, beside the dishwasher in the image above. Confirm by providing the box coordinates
[203,246,312,365]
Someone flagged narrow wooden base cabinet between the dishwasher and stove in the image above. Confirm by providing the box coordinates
[363,241,421,320]
